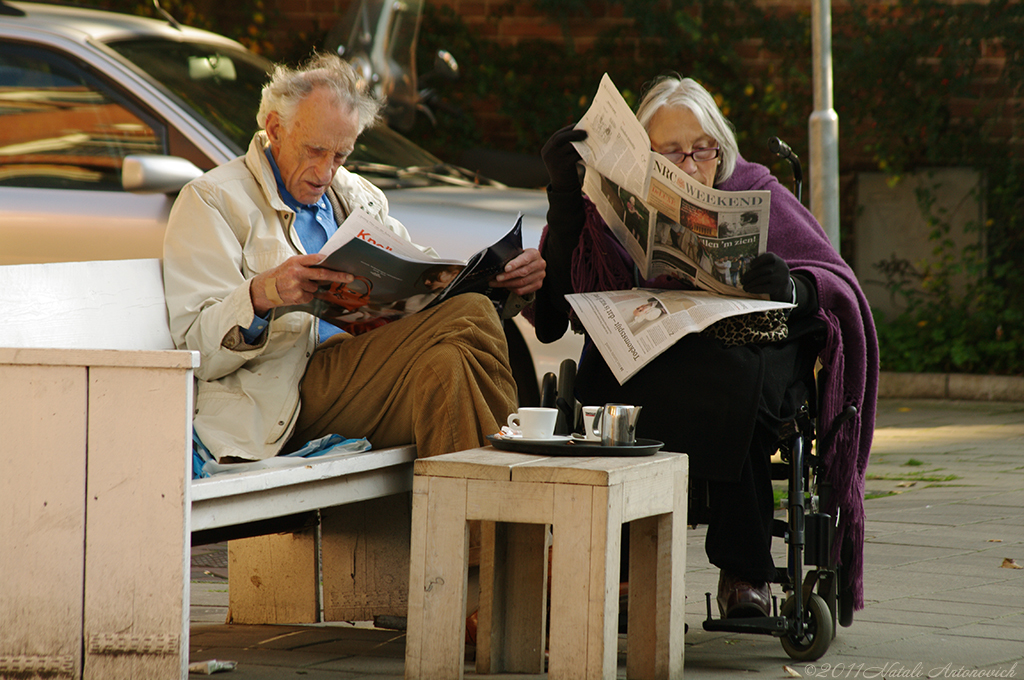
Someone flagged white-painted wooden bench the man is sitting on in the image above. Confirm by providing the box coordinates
[0,260,416,679]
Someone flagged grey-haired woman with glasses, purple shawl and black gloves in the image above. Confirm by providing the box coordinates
[531,76,878,659]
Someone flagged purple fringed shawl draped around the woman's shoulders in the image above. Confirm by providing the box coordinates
[542,158,879,609]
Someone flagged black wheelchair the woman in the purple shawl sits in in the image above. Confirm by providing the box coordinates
[541,137,857,662]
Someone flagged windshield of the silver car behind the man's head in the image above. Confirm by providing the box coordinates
[110,39,468,185]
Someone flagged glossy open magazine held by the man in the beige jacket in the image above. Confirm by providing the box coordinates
[280,210,522,335]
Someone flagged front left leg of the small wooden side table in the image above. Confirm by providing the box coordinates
[406,477,469,680]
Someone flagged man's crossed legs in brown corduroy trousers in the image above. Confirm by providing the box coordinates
[288,294,517,457]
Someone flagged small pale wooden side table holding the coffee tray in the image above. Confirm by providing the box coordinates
[406,448,687,680]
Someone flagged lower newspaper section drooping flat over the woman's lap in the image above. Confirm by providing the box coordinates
[565,288,793,384]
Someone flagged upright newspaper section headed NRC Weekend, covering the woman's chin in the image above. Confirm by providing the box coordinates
[573,74,771,298]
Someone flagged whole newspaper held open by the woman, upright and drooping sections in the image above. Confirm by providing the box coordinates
[566,74,793,384]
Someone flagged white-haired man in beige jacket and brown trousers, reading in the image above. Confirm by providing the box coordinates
[164,55,546,462]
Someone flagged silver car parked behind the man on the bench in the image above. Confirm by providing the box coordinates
[0,0,581,403]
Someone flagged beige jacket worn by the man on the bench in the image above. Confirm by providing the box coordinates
[164,132,421,460]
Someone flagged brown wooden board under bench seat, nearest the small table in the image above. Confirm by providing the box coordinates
[321,494,412,621]
